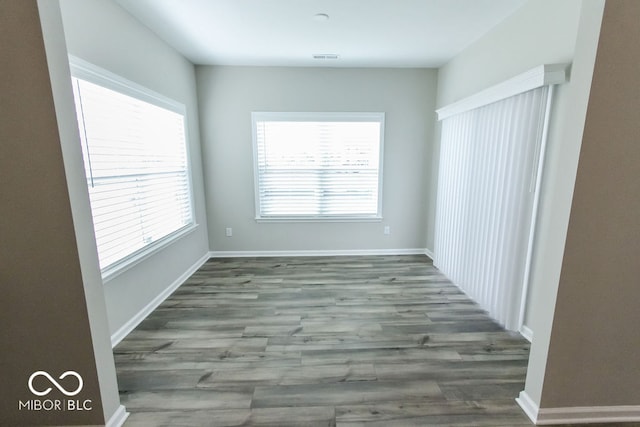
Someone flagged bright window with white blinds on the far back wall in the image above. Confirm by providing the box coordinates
[252,113,384,220]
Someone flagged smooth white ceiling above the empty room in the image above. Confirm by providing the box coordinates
[116,0,525,67]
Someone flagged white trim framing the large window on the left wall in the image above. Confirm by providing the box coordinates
[69,55,199,284]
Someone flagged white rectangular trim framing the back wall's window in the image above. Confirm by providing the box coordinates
[251,111,385,223]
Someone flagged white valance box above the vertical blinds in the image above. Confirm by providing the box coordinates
[436,64,568,120]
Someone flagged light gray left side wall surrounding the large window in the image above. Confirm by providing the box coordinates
[60,0,208,334]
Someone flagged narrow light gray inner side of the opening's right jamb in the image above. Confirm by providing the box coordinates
[525,0,604,403]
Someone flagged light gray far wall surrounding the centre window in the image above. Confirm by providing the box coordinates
[197,66,436,251]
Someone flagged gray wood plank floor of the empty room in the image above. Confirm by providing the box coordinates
[114,256,532,427]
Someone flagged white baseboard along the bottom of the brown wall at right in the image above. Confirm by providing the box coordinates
[516,391,640,425]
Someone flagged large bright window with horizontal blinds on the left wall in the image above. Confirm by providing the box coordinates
[72,59,194,278]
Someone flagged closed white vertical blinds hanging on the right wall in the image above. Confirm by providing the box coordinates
[435,86,549,329]
